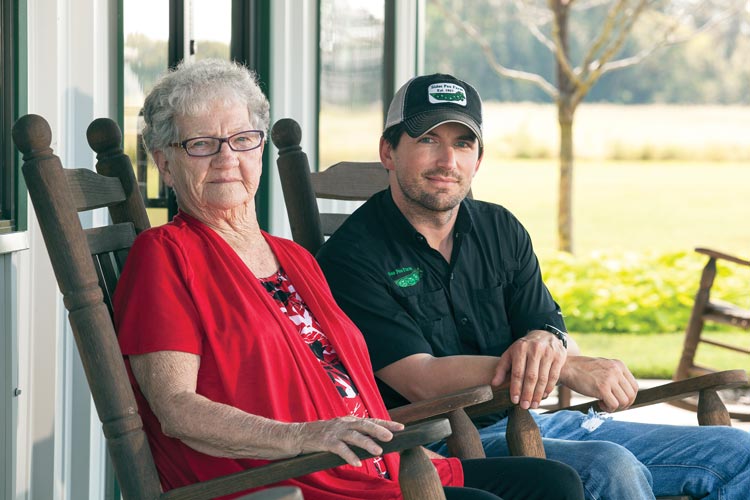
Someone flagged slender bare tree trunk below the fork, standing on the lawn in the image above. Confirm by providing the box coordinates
[557,105,575,253]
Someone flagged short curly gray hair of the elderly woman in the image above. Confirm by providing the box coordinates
[142,59,270,154]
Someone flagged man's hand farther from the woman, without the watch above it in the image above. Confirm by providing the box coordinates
[560,356,638,412]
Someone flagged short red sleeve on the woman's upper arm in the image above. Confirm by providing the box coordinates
[113,229,202,355]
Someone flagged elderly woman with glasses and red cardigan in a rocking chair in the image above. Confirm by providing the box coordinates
[114,60,582,499]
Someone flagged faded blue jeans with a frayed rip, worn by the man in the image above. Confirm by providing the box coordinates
[432,411,750,500]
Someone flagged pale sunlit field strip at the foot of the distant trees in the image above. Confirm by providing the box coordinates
[484,102,750,161]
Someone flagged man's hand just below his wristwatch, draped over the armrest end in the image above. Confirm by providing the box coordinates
[491,330,567,409]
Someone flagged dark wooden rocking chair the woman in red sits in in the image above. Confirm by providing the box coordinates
[13,115,506,500]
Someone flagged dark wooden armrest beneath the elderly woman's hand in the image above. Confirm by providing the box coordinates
[160,419,451,500]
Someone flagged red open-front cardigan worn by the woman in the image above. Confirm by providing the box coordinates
[114,213,463,500]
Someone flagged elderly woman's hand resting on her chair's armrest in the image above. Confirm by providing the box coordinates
[291,417,404,467]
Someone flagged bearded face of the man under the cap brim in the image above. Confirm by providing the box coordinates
[380,123,481,212]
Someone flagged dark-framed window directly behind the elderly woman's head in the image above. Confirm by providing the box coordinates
[122,0,270,226]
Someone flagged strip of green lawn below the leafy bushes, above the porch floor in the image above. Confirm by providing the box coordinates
[575,330,750,379]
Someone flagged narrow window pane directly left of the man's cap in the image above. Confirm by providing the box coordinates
[318,0,385,169]
